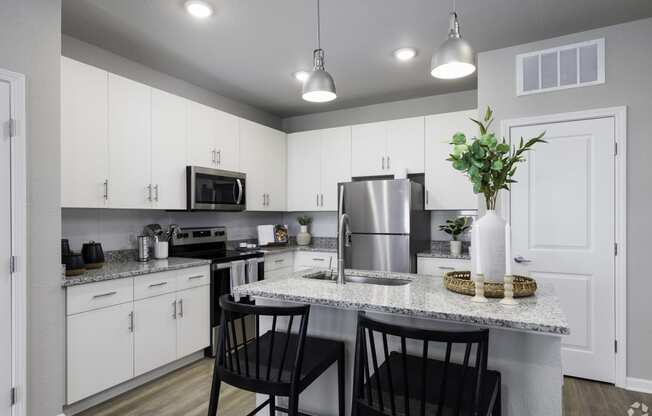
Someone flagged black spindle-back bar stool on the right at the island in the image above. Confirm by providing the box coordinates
[352,313,501,416]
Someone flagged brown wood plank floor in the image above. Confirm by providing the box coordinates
[79,359,652,416]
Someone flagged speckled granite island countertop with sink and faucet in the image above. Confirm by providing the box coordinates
[233,269,570,335]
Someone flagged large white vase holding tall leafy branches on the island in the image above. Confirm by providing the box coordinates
[471,210,506,282]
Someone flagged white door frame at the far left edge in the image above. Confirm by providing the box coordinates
[0,69,27,416]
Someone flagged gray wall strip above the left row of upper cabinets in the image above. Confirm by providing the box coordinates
[61,35,282,129]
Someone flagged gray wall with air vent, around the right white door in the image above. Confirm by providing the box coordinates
[478,19,652,380]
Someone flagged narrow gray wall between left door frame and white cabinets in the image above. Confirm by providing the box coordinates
[0,0,65,416]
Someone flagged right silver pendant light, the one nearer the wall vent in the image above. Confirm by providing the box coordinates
[430,0,475,79]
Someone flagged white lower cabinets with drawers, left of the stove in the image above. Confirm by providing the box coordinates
[66,266,210,404]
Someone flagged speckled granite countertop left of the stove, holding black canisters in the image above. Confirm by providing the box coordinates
[61,257,211,287]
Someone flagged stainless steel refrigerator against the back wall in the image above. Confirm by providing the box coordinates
[338,179,430,273]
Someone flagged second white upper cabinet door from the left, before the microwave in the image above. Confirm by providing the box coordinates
[109,74,152,208]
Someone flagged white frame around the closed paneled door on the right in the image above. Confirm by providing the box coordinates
[500,106,627,388]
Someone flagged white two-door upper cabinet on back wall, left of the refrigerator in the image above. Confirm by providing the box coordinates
[288,127,351,211]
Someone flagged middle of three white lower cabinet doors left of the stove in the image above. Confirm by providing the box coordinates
[134,293,177,376]
